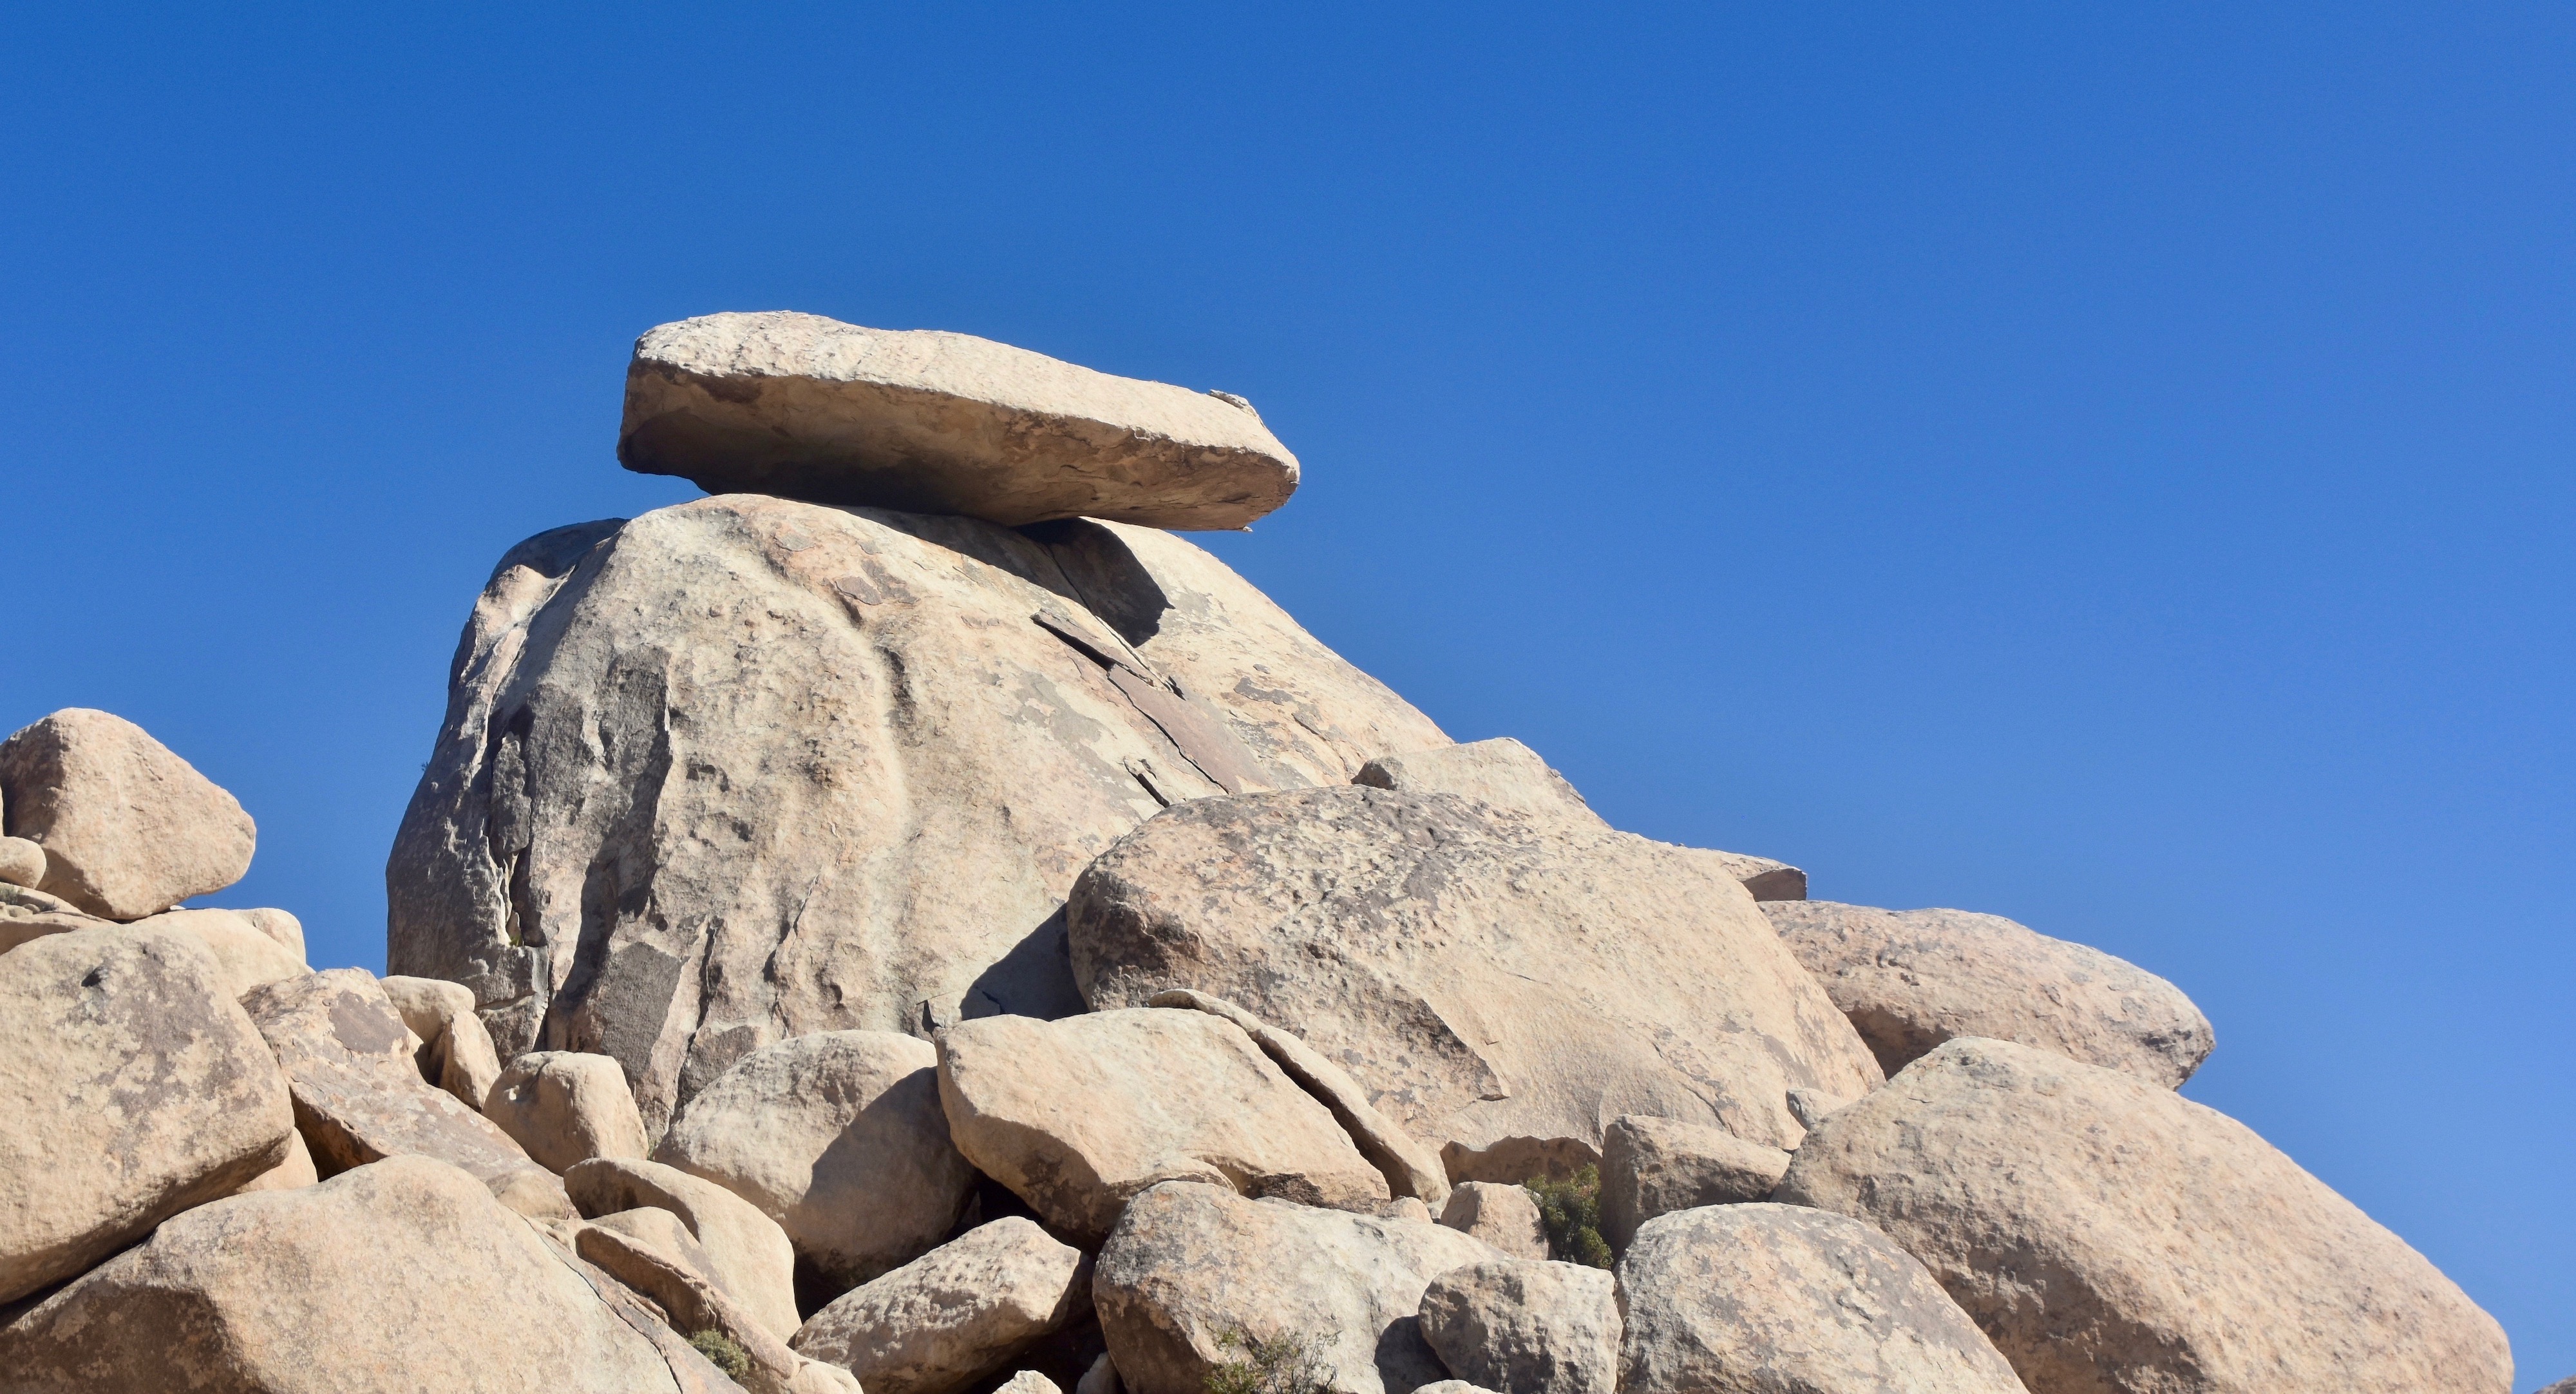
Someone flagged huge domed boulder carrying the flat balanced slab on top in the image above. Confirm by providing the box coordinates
[386,495,1445,1136]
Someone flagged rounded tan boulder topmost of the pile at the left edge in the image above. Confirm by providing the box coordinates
[0,706,258,920]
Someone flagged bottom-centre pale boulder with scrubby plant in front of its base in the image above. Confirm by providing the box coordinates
[1092,1183,1497,1394]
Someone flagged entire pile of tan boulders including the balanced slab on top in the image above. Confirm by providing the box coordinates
[0,314,2512,1394]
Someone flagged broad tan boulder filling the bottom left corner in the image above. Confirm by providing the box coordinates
[0,1157,721,1394]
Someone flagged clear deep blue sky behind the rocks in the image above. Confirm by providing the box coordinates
[0,3,2576,1389]
